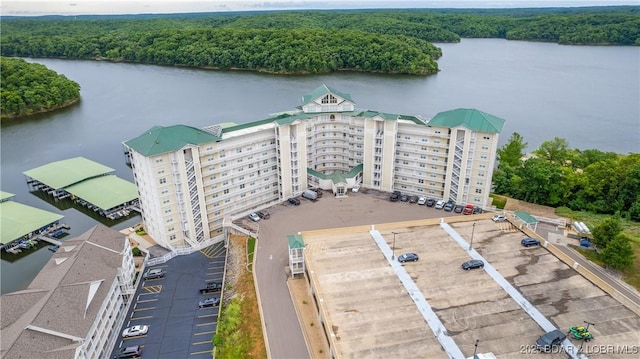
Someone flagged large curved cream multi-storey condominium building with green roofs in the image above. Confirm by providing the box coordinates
[124,85,504,248]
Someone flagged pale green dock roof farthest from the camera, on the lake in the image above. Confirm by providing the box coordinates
[23,157,114,189]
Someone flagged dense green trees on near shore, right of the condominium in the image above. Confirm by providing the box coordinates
[493,132,640,222]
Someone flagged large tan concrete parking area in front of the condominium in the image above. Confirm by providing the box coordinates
[251,191,640,358]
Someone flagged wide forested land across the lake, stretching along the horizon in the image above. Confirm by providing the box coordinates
[0,6,640,75]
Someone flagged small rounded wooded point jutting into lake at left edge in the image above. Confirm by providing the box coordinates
[0,57,80,119]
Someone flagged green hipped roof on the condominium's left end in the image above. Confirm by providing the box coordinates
[124,125,220,157]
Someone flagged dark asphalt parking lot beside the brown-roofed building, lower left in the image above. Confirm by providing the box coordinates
[112,243,226,359]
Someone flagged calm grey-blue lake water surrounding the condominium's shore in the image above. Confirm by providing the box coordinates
[0,39,640,293]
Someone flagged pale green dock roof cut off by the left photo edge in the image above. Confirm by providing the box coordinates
[0,201,63,245]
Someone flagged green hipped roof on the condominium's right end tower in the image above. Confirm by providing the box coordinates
[427,108,505,133]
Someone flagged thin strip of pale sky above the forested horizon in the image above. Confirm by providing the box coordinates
[0,0,640,16]
